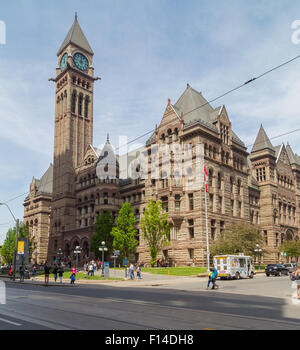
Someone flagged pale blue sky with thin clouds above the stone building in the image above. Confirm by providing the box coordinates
[0,0,300,243]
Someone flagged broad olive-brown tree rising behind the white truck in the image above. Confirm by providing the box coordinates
[210,222,266,256]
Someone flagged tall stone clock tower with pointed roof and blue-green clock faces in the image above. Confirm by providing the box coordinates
[48,14,99,258]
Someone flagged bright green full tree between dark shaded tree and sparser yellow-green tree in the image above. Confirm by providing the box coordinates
[111,203,139,259]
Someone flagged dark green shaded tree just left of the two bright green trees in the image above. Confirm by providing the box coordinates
[91,210,114,258]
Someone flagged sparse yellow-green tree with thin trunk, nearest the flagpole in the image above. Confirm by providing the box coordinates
[141,199,170,267]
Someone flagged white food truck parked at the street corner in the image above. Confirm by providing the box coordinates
[214,254,255,280]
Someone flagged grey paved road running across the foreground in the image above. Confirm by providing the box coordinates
[0,276,300,330]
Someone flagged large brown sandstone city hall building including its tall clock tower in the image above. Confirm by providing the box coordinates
[24,16,300,266]
